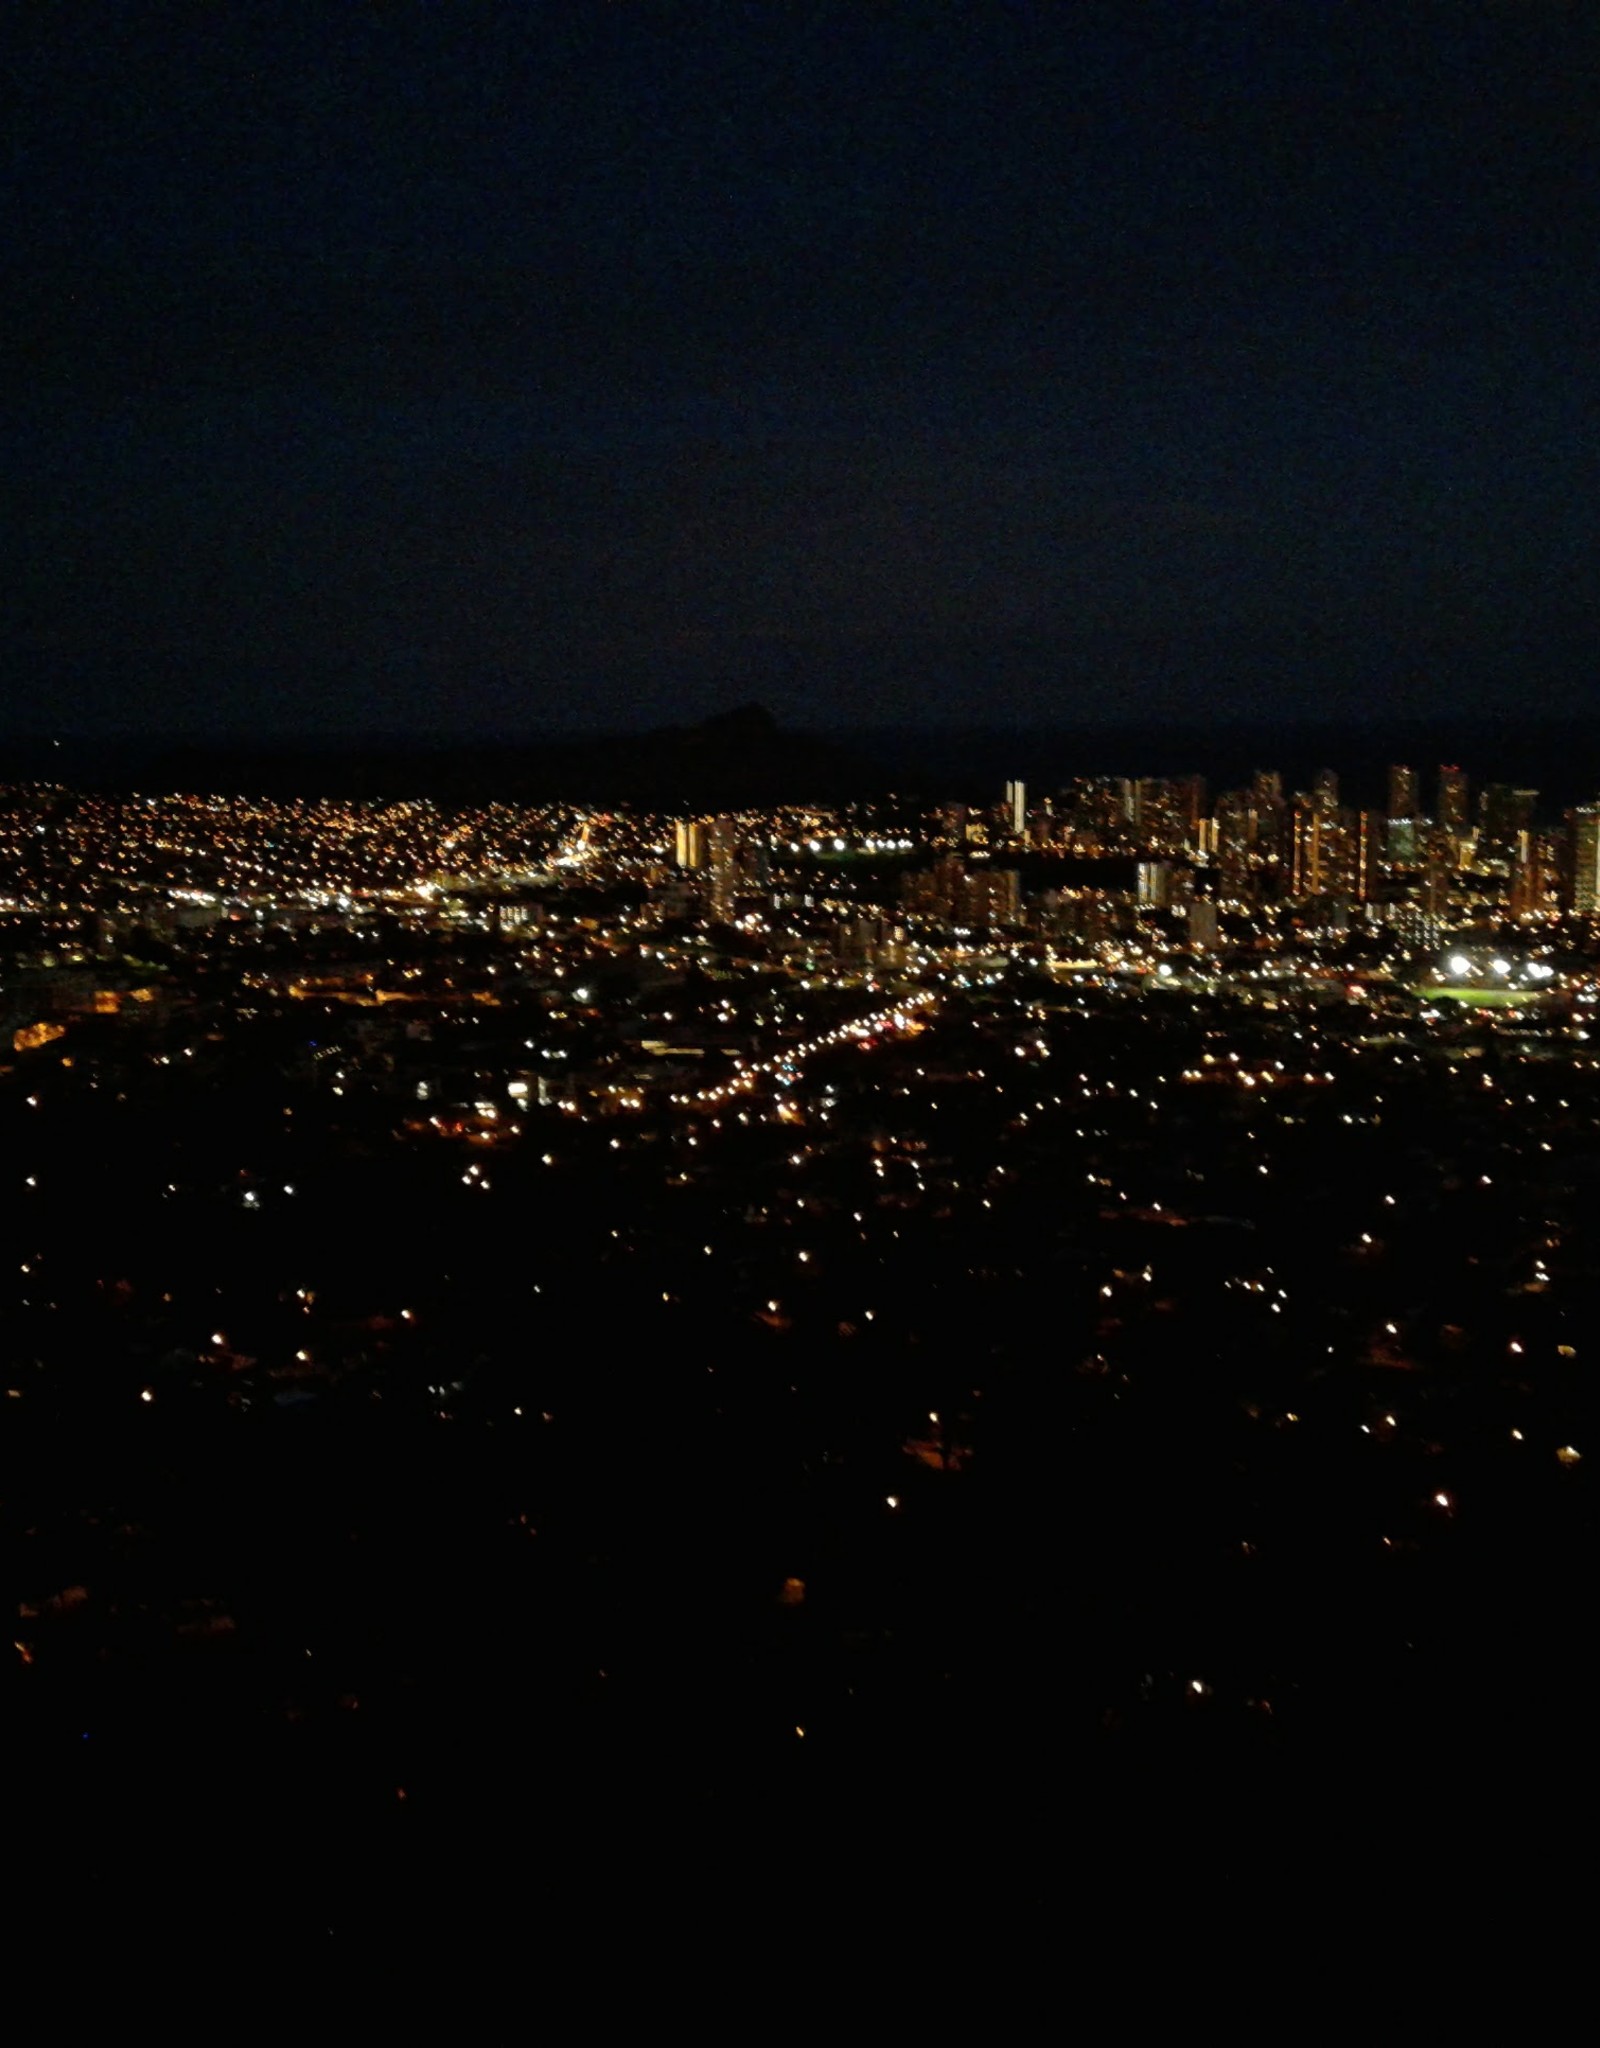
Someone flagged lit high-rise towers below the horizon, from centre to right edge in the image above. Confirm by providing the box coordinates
[659,762,1600,966]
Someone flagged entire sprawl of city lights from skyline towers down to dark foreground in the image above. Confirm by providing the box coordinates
[0,754,1600,1942]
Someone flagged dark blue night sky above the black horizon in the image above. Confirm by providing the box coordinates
[0,0,1600,735]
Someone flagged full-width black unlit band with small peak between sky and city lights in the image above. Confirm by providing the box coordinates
[12,705,1600,798]
